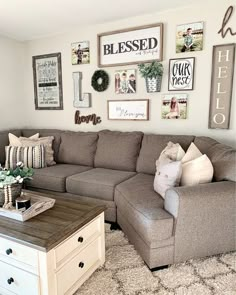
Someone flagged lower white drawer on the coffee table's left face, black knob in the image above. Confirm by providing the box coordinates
[0,261,40,295]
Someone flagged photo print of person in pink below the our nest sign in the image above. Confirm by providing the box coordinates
[161,93,188,119]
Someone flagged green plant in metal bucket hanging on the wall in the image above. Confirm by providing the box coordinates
[138,61,163,93]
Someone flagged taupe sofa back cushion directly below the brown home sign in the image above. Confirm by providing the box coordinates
[58,131,98,166]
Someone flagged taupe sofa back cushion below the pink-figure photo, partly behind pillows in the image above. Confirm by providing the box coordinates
[137,134,194,174]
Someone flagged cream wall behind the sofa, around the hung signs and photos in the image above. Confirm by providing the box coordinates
[25,0,236,146]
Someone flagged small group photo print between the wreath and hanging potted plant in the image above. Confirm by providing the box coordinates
[115,70,136,94]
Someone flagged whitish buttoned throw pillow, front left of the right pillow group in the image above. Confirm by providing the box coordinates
[154,155,182,198]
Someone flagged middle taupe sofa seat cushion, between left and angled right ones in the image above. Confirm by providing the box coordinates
[66,168,136,201]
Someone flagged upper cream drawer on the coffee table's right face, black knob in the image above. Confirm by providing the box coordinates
[55,215,103,266]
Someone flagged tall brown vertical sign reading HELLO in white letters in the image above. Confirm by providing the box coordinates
[209,44,235,129]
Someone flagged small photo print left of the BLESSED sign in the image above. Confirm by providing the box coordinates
[71,41,90,65]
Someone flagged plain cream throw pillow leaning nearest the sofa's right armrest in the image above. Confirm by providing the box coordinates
[181,155,214,186]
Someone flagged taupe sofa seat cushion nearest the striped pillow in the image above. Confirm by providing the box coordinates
[28,164,92,192]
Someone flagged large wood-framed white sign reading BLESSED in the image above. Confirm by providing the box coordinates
[97,23,163,68]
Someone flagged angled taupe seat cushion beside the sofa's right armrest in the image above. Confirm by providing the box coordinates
[115,173,174,247]
